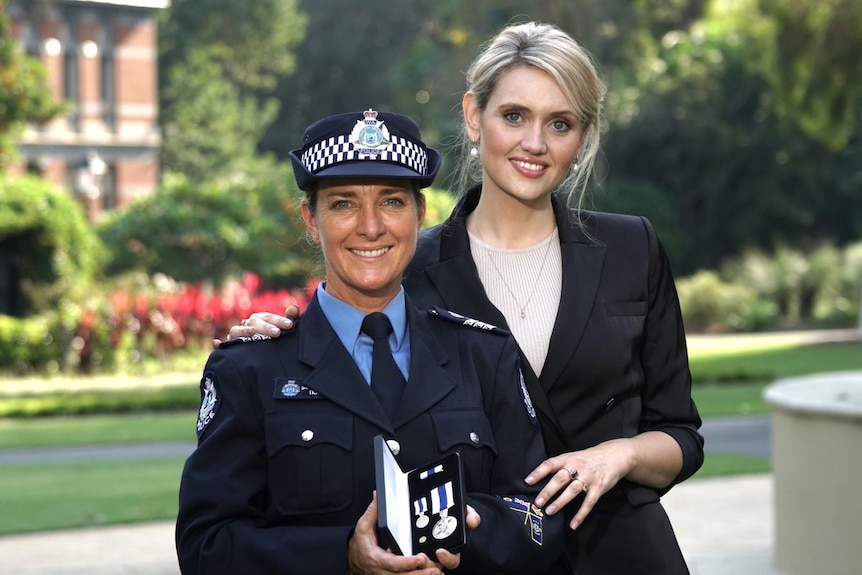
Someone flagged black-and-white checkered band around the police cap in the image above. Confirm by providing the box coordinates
[302,136,428,175]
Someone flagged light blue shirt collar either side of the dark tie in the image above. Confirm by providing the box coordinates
[317,282,410,384]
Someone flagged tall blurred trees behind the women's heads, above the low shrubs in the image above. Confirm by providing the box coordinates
[154,0,862,275]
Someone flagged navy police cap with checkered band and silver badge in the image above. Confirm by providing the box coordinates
[290,109,443,191]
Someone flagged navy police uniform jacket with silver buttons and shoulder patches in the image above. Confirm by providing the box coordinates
[176,296,565,575]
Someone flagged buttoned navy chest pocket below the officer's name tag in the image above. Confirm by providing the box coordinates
[265,412,353,515]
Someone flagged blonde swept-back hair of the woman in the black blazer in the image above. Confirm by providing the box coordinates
[455,22,605,212]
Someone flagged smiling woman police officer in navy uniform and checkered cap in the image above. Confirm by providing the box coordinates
[176,110,564,575]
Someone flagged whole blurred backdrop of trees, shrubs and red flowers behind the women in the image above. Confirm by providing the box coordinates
[0,0,862,378]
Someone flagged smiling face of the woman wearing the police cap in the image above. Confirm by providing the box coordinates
[302,179,425,313]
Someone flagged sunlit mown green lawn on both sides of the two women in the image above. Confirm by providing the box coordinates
[0,337,862,534]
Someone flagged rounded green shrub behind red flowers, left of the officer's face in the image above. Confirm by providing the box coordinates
[100,162,313,285]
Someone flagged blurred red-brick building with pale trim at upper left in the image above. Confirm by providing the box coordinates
[5,0,170,220]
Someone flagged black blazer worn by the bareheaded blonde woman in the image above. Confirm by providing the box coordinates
[404,188,703,575]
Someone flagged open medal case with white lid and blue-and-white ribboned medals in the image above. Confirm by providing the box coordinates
[374,435,467,559]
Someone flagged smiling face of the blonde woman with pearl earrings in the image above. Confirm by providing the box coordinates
[470,65,582,209]
